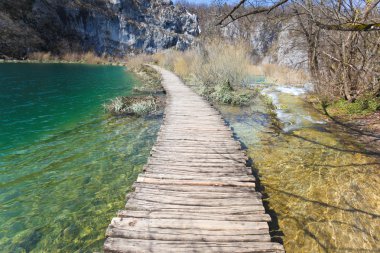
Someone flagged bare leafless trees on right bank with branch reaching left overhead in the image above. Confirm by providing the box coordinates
[217,0,380,101]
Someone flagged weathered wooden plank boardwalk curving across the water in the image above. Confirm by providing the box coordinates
[104,67,284,253]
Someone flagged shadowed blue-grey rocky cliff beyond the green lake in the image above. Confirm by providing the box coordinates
[0,0,199,58]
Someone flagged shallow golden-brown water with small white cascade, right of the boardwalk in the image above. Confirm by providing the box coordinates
[220,87,380,253]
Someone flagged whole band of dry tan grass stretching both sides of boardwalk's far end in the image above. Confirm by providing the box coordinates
[127,39,309,104]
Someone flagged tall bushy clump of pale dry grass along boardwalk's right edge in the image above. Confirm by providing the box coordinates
[154,39,254,105]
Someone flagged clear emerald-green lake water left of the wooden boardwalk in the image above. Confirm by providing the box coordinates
[0,64,161,252]
